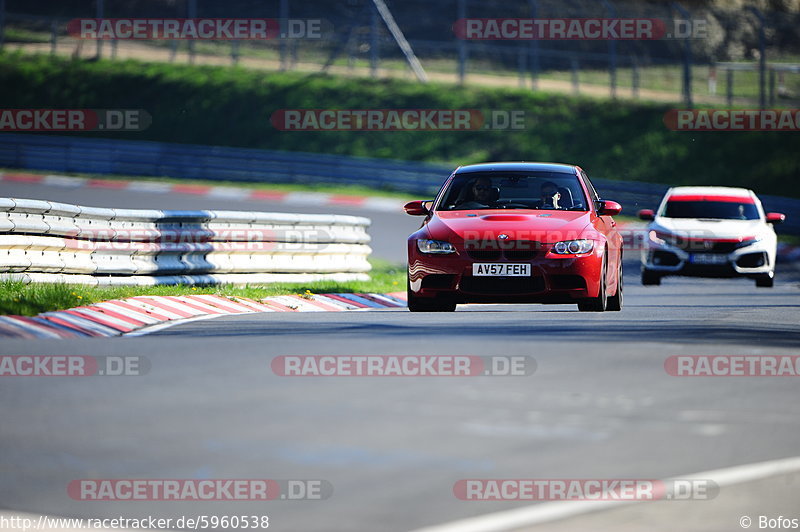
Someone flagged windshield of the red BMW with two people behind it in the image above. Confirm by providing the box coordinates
[437,172,587,211]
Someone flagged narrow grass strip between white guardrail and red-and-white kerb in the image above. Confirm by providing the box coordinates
[0,259,406,316]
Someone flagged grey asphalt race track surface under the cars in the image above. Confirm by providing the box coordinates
[0,181,800,531]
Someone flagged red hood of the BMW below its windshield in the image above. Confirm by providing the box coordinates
[427,209,590,243]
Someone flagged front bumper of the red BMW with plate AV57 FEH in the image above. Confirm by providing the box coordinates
[408,240,604,303]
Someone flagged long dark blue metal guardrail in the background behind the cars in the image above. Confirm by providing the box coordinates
[0,133,800,235]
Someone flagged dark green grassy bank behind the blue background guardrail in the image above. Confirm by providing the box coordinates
[0,53,800,197]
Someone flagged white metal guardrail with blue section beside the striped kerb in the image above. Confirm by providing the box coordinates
[0,198,371,285]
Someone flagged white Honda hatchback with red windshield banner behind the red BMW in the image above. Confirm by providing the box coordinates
[639,187,786,287]
